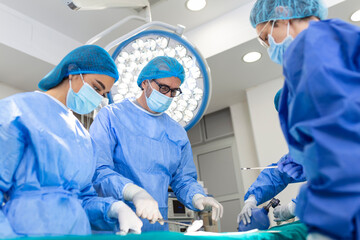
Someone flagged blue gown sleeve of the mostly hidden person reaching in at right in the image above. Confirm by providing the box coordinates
[244,156,304,204]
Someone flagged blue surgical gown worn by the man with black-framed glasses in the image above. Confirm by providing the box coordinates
[90,99,205,232]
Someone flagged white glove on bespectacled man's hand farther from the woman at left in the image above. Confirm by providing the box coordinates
[192,194,224,221]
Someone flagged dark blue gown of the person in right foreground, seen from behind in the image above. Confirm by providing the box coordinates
[279,19,360,239]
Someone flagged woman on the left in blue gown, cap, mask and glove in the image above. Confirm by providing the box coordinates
[0,45,142,238]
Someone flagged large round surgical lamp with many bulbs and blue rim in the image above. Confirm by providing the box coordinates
[67,0,211,130]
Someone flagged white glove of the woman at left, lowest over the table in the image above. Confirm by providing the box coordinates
[107,201,143,235]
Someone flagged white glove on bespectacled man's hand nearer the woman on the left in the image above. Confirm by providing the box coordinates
[123,184,164,224]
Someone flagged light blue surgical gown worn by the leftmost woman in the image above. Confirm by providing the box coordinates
[0,92,117,237]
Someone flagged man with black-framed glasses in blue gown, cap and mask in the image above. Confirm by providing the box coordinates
[90,57,223,231]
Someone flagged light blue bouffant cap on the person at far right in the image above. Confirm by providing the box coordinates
[250,0,328,28]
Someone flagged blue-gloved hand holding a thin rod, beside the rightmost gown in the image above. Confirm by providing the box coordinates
[277,155,306,181]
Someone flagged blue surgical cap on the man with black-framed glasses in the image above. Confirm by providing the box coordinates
[137,56,185,87]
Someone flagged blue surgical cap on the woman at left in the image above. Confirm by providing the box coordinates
[38,45,119,91]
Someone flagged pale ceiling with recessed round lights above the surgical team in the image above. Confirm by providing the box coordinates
[0,0,360,112]
